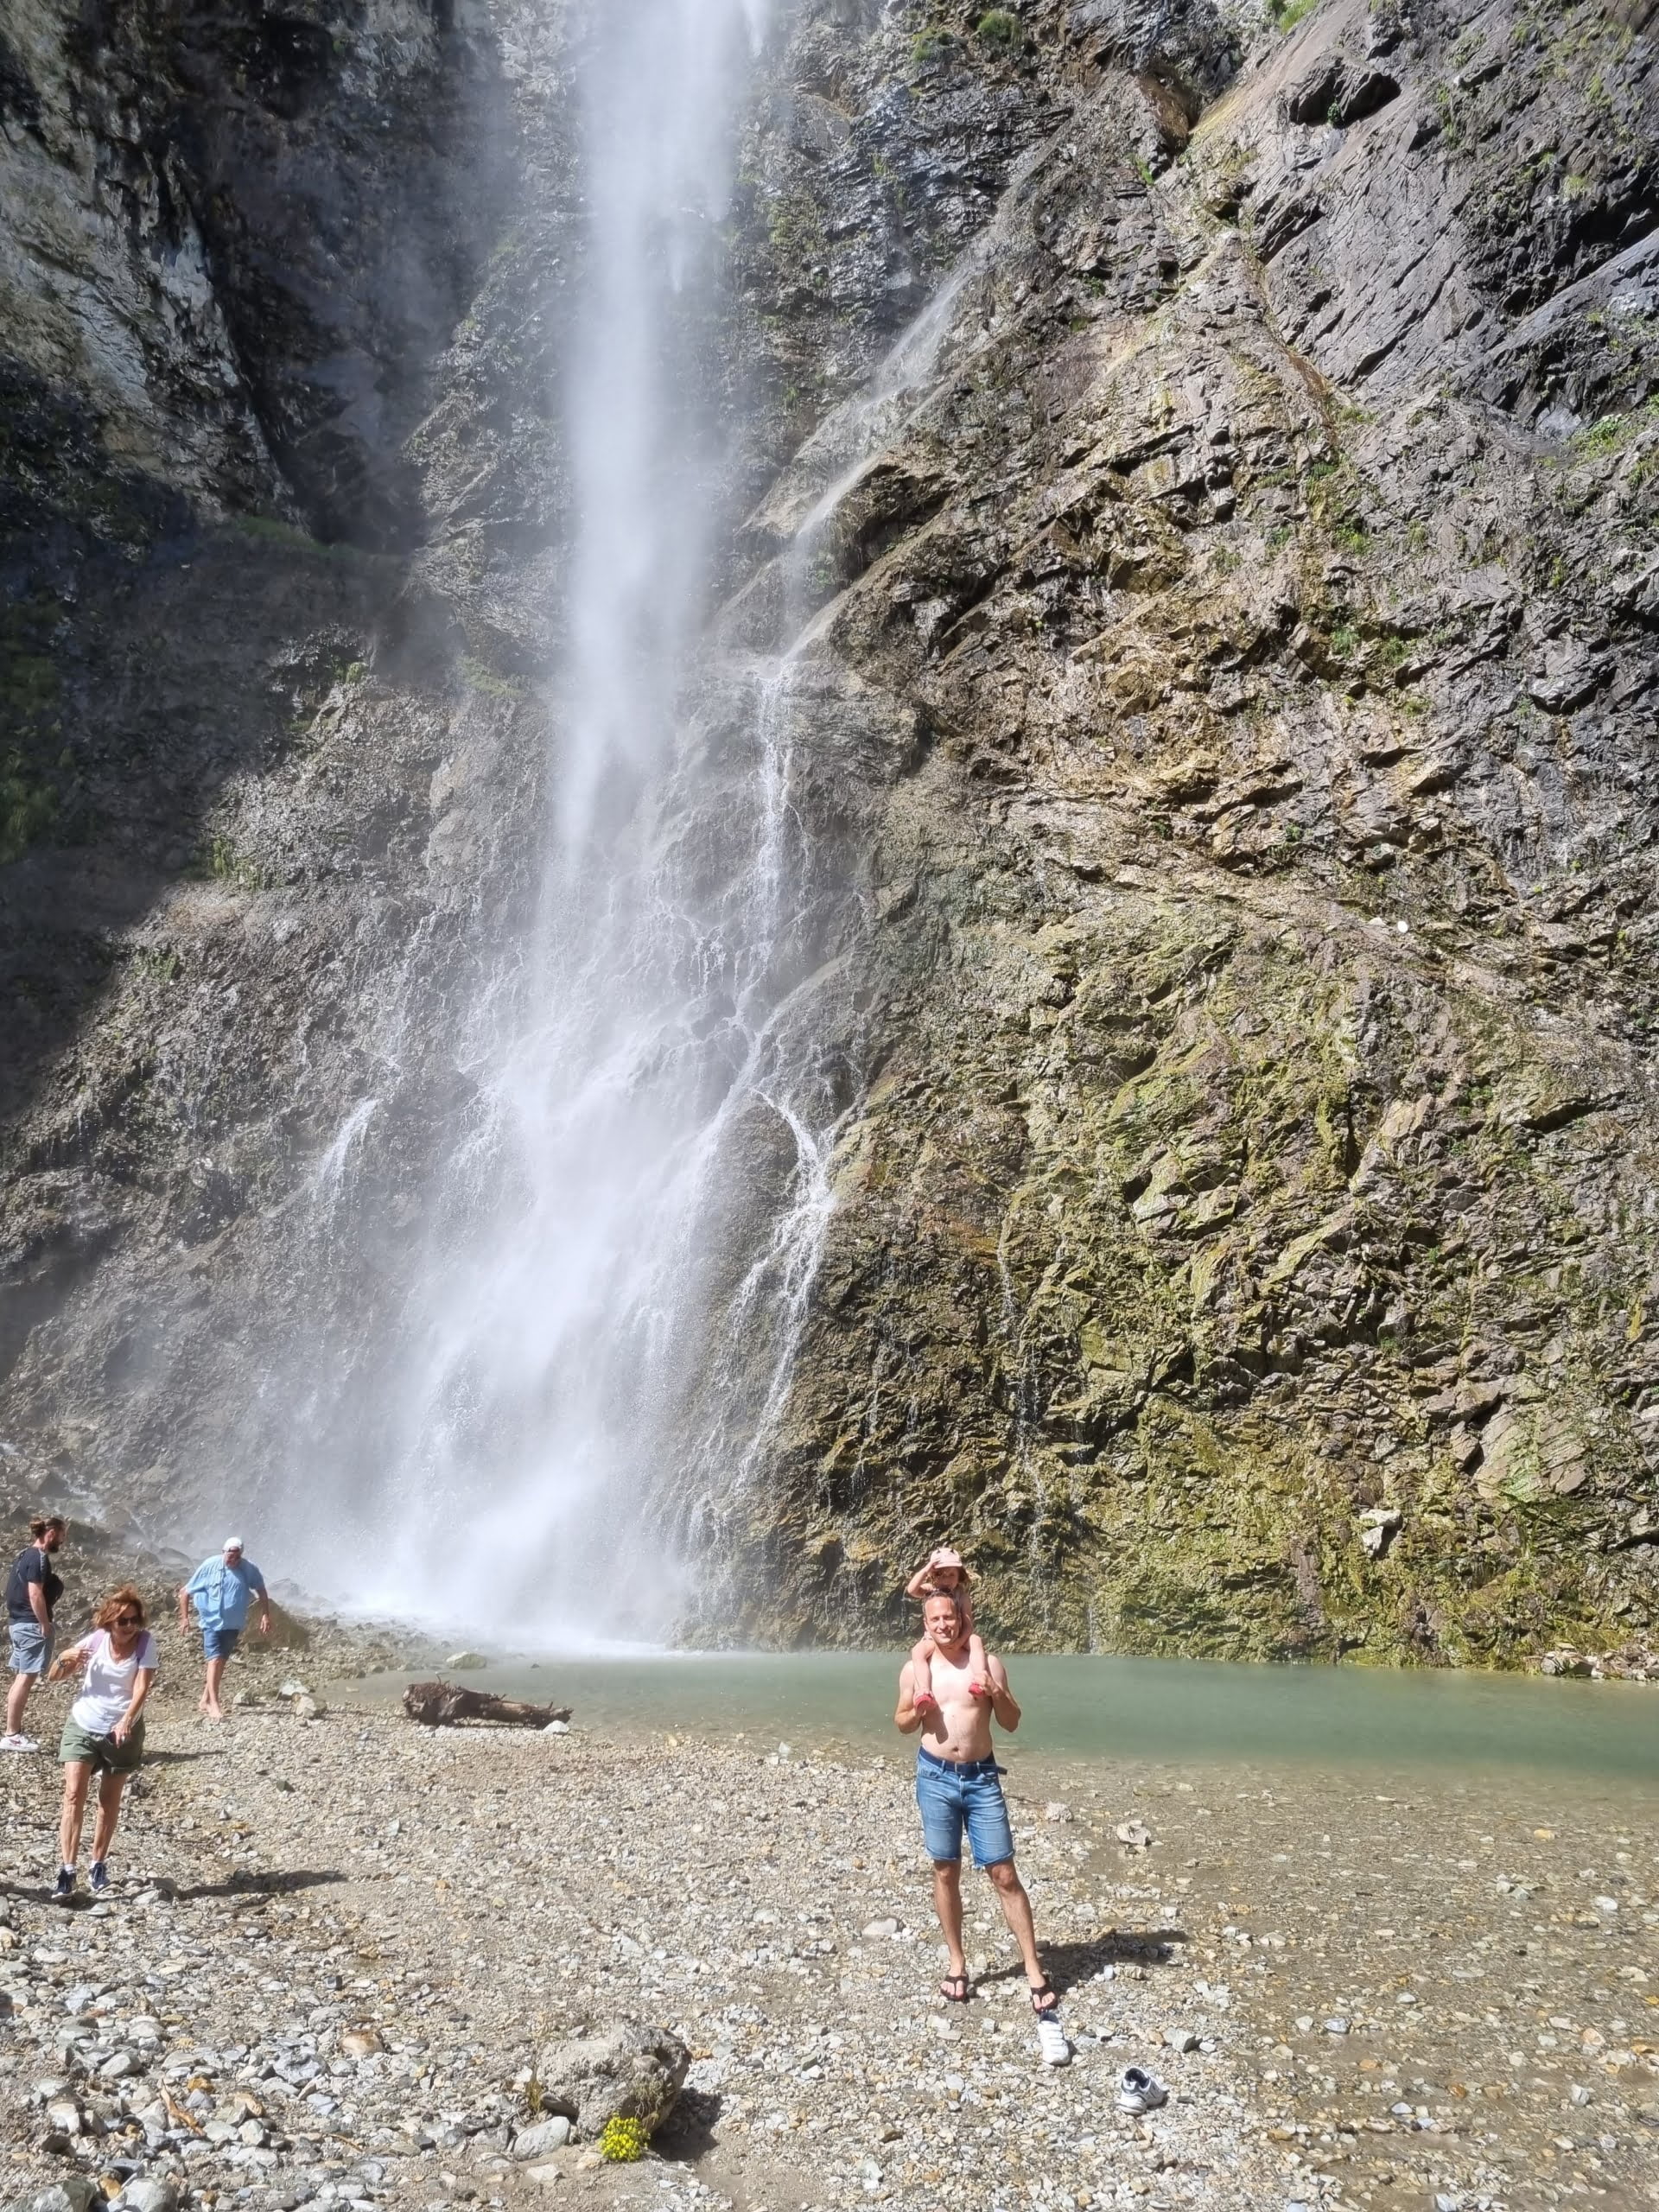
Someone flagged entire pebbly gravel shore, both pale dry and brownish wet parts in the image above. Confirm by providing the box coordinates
[0,1632,1659,2212]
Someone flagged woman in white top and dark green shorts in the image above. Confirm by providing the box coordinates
[47,1584,159,1904]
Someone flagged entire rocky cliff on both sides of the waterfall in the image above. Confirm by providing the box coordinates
[0,0,1659,1659]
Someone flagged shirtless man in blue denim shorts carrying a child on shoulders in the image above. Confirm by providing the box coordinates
[893,1595,1066,2057]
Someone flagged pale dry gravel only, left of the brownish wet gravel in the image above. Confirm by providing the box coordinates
[0,1692,1285,2212]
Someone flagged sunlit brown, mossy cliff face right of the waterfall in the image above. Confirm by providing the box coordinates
[690,7,1659,1663]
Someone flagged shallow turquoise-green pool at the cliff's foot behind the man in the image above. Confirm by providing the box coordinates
[352,1652,1659,1785]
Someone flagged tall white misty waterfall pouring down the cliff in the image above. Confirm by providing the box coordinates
[327,0,800,1646]
